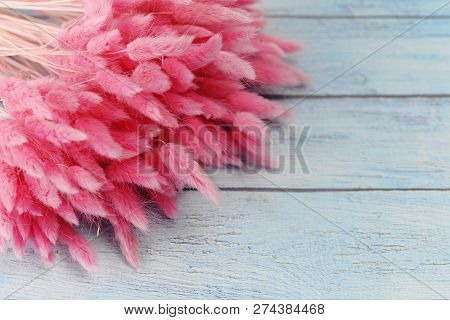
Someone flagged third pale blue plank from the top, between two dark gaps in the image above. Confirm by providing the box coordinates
[212,98,450,189]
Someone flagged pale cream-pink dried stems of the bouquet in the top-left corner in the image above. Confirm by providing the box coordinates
[0,0,83,78]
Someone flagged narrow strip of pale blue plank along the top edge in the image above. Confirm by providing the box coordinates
[259,0,450,18]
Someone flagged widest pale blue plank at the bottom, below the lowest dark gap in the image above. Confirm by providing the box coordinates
[0,192,450,299]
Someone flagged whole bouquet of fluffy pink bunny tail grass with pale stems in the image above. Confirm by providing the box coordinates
[0,0,305,270]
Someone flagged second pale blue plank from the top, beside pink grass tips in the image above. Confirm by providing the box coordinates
[265,18,450,96]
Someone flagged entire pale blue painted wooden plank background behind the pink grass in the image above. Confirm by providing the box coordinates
[0,0,450,299]
